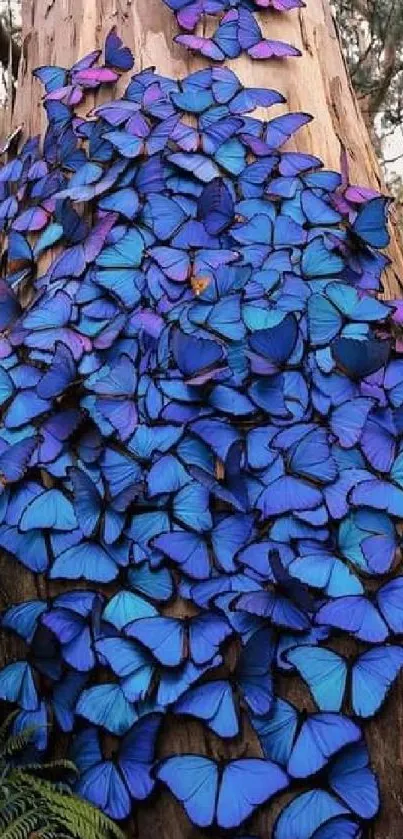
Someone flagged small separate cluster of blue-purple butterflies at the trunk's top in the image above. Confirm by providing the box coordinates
[163,0,305,61]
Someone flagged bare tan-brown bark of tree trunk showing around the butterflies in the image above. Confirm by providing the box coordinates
[6,0,403,839]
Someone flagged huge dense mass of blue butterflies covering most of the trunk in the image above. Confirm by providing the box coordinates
[0,18,403,839]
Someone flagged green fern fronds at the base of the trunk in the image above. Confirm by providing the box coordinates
[0,715,124,839]
